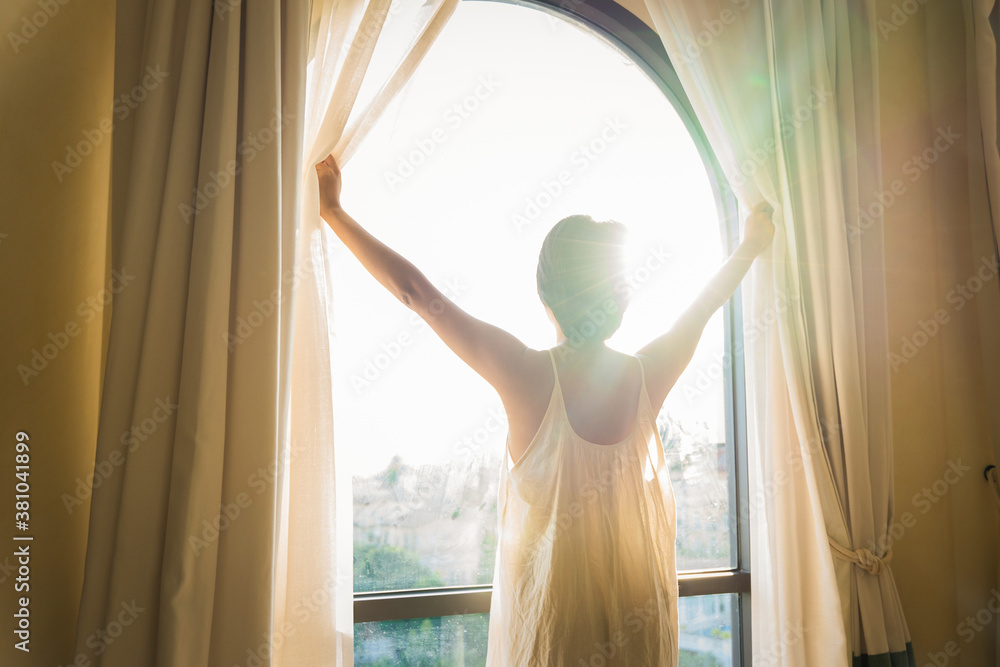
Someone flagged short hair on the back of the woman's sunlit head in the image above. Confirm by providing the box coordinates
[536,215,629,344]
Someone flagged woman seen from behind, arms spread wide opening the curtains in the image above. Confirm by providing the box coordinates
[316,155,774,667]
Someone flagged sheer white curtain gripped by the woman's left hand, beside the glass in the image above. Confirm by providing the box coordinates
[274,0,458,667]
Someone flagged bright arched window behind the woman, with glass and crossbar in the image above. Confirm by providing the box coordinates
[332,0,750,665]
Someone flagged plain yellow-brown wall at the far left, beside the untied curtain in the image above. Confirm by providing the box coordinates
[0,0,114,667]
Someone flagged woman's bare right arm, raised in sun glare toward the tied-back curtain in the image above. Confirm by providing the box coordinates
[638,203,774,410]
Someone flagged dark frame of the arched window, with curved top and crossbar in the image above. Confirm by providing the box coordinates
[354,0,752,667]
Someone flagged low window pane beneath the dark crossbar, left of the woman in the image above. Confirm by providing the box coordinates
[354,614,489,667]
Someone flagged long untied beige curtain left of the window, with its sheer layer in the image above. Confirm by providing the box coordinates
[77,0,455,667]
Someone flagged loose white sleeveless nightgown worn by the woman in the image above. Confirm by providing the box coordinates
[486,350,678,667]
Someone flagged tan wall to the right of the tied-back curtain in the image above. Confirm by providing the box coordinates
[878,0,1000,667]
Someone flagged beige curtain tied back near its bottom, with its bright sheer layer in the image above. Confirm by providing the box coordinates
[646,0,914,667]
